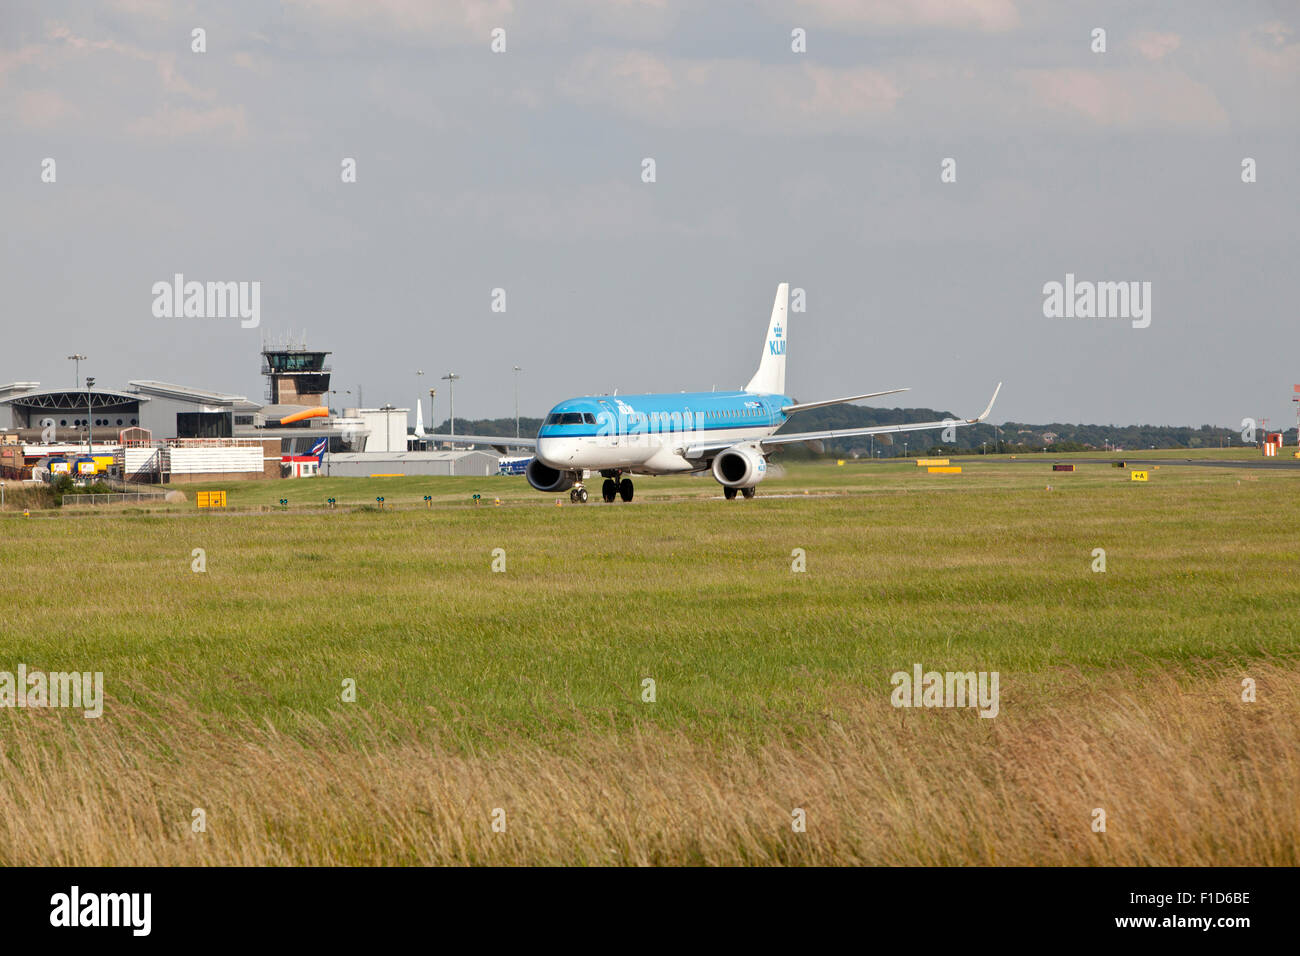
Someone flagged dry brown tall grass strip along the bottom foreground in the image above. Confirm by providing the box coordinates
[0,663,1300,865]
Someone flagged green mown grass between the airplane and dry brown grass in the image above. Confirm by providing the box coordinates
[0,458,1300,745]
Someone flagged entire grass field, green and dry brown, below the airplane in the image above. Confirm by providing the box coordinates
[0,453,1300,865]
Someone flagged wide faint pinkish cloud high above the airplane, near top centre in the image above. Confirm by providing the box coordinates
[558,51,902,133]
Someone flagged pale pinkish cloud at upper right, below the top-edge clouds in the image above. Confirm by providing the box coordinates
[1017,69,1227,130]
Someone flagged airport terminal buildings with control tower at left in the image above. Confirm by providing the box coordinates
[0,342,517,483]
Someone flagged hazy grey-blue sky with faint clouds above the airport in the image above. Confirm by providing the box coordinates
[0,0,1300,427]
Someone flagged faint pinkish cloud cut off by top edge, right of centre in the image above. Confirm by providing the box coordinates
[774,0,1021,33]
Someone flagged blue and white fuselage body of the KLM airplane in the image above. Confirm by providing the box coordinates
[537,392,793,475]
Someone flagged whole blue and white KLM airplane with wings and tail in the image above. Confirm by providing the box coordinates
[429,282,1002,503]
